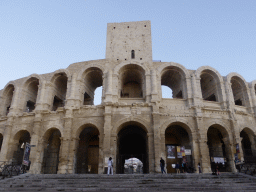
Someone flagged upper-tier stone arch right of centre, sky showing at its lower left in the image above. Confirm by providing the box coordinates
[157,63,190,99]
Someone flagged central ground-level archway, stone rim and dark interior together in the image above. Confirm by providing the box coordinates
[115,119,152,174]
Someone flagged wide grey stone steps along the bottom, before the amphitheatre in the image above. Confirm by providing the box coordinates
[0,173,256,192]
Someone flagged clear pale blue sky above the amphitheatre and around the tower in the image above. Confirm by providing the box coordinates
[0,0,256,89]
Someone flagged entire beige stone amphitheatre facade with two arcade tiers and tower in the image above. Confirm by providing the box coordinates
[0,21,256,174]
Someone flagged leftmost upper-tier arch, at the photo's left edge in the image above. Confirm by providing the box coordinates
[0,82,15,115]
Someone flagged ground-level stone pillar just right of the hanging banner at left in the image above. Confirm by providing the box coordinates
[29,113,42,174]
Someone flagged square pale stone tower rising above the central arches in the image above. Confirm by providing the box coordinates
[106,21,152,62]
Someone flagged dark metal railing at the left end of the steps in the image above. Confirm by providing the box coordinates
[0,161,26,179]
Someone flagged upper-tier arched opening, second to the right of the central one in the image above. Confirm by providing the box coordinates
[200,70,219,101]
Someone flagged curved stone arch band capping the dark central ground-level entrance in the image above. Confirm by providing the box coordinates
[111,117,153,135]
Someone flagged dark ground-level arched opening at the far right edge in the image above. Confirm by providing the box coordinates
[240,128,256,163]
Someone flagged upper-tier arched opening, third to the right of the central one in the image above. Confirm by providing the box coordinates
[231,76,246,106]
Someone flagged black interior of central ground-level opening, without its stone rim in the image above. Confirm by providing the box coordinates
[116,122,149,174]
